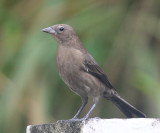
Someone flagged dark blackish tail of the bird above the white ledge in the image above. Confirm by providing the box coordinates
[104,95,146,118]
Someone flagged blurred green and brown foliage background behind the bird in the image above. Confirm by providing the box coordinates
[0,0,160,133]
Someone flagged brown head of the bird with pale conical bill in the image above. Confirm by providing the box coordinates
[42,24,76,43]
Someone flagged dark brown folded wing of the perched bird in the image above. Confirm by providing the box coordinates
[81,53,114,89]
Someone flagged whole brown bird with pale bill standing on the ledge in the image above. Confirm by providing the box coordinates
[42,24,146,119]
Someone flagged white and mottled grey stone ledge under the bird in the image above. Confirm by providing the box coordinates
[26,118,160,133]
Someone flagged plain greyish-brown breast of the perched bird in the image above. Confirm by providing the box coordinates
[56,46,83,87]
